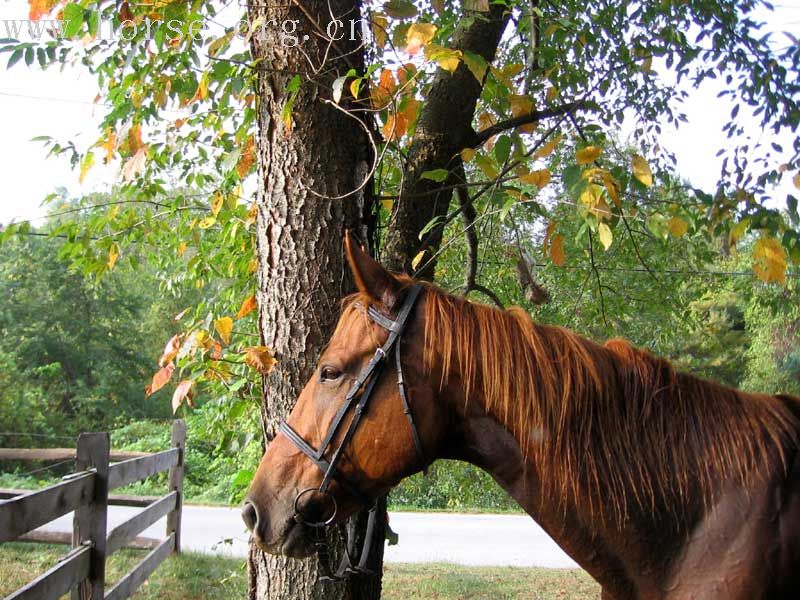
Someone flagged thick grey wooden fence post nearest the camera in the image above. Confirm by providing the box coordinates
[72,433,110,600]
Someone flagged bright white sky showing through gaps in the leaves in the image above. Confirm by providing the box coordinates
[0,0,800,224]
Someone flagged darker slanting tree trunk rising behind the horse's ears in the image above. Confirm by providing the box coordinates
[381,3,508,279]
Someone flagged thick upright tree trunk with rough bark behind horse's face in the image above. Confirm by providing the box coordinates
[249,0,384,600]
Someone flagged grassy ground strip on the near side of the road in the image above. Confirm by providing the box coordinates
[0,544,600,600]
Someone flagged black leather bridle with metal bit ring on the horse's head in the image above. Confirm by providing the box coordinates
[278,285,427,581]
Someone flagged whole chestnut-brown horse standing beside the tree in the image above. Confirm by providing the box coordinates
[243,239,800,600]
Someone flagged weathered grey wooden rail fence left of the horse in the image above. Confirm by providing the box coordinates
[0,420,186,600]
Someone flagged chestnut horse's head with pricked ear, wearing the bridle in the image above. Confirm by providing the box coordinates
[242,236,446,557]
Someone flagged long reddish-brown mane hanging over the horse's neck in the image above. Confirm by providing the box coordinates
[412,285,800,522]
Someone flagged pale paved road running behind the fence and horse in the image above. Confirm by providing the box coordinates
[36,506,577,568]
